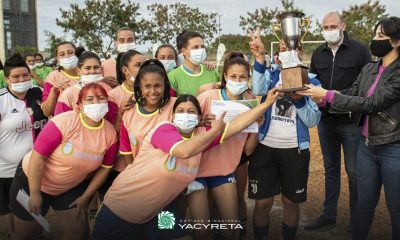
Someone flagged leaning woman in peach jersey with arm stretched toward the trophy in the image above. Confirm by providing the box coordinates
[92,91,278,240]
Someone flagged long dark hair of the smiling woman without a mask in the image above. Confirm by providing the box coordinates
[133,59,171,111]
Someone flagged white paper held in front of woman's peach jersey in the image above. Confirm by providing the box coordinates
[211,99,258,133]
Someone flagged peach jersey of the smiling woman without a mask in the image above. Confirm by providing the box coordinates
[114,97,176,172]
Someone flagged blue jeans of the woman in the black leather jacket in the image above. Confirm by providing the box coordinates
[354,137,400,240]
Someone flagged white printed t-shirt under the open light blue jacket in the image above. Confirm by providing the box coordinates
[261,76,299,148]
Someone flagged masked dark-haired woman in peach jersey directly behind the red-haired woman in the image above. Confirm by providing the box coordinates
[54,51,111,116]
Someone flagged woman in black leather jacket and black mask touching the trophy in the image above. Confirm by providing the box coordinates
[298,17,400,240]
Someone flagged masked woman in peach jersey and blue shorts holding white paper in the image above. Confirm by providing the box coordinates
[188,52,257,239]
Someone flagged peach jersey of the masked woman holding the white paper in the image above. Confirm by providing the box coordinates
[197,89,254,177]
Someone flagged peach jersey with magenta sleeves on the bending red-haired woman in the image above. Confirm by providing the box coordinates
[22,111,118,196]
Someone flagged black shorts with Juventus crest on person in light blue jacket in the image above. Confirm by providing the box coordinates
[248,143,310,203]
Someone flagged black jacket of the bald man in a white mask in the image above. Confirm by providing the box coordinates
[310,32,372,119]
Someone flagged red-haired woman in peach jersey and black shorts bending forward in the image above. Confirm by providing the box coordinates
[10,83,117,239]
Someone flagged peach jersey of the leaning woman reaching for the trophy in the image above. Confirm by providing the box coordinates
[104,122,221,223]
